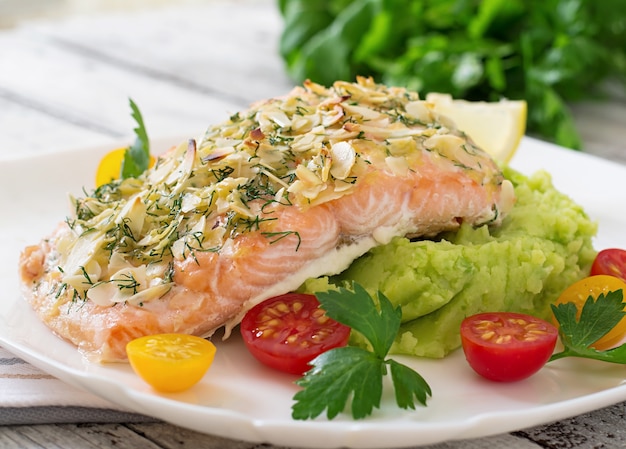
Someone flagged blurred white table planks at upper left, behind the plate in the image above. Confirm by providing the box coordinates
[0,2,292,157]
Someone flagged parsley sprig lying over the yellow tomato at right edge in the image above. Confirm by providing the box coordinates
[550,289,626,364]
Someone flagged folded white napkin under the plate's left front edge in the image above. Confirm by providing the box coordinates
[0,347,151,425]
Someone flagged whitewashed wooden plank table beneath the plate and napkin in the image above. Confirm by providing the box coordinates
[0,0,626,449]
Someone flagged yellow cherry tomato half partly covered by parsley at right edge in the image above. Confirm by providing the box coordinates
[554,275,626,351]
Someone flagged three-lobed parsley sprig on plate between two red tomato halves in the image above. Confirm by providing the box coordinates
[292,283,432,420]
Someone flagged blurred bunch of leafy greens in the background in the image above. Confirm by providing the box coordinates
[278,0,626,148]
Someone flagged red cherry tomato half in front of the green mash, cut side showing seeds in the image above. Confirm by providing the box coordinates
[461,312,558,382]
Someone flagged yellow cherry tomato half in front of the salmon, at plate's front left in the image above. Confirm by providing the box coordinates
[126,334,216,393]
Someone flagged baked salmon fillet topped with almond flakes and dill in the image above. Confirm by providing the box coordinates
[20,78,514,361]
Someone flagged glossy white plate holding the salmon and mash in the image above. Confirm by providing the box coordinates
[0,138,626,448]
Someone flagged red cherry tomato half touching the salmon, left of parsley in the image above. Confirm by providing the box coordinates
[240,293,350,375]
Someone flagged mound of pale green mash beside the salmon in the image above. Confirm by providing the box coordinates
[302,169,597,358]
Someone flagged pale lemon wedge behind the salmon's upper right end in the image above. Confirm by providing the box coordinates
[426,93,527,164]
